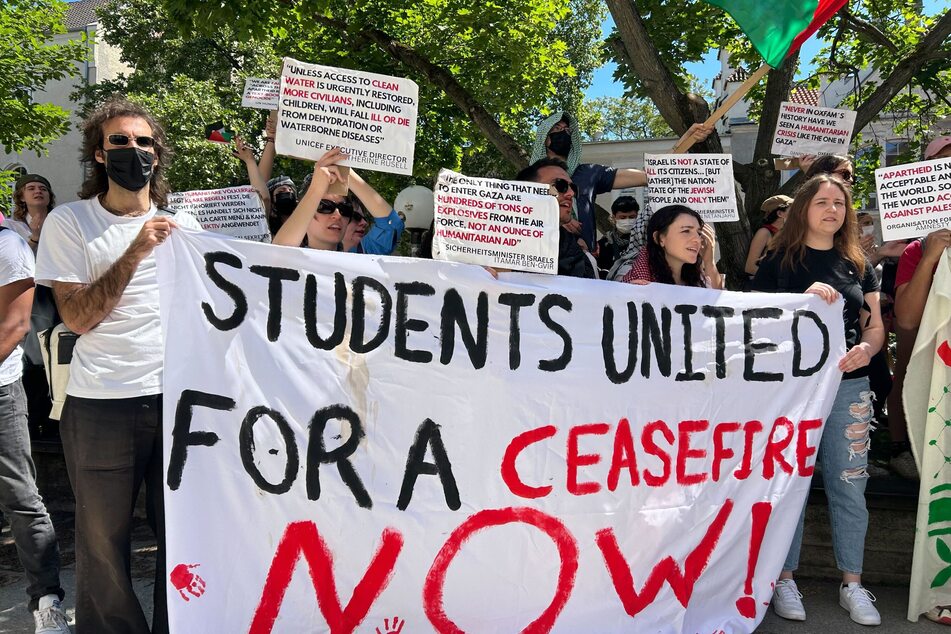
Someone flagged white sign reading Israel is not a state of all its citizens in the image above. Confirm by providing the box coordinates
[644,154,740,222]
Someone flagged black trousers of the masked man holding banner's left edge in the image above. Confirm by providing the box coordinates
[60,395,168,634]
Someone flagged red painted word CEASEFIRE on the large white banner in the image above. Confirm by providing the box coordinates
[501,416,822,499]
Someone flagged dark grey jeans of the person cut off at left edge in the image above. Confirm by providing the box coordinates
[0,379,63,610]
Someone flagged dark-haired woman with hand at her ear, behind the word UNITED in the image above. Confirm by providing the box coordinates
[622,205,723,288]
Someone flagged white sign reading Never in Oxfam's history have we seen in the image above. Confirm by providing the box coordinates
[771,101,855,156]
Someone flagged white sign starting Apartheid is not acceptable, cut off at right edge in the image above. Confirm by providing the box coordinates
[875,158,951,241]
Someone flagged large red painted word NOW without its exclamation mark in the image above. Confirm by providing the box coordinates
[249,500,733,634]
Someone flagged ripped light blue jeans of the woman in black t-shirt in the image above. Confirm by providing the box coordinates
[783,377,874,575]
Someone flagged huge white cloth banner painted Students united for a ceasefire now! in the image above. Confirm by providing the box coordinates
[156,230,845,634]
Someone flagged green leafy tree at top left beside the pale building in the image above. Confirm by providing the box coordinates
[0,0,86,198]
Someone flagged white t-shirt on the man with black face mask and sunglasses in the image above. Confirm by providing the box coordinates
[36,197,201,399]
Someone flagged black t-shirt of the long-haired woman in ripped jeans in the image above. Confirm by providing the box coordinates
[750,247,879,379]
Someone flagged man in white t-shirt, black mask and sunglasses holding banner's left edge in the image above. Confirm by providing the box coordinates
[36,98,201,634]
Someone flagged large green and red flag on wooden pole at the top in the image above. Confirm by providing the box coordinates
[704,0,848,68]
